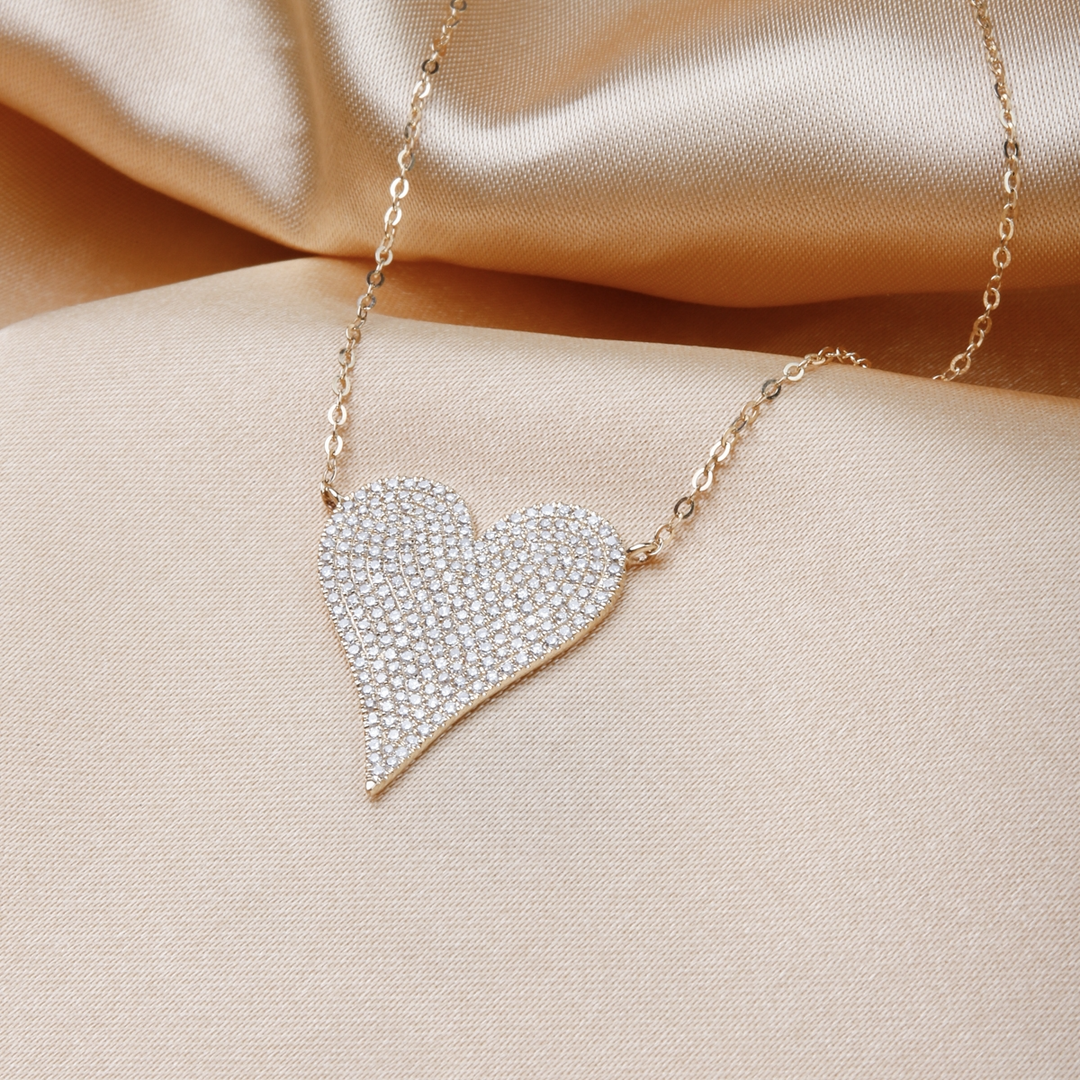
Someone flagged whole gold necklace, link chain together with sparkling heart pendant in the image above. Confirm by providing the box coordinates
[319,0,1021,795]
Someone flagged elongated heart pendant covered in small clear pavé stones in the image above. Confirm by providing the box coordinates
[319,478,625,795]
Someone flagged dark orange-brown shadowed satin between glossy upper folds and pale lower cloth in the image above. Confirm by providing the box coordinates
[0,98,1080,397]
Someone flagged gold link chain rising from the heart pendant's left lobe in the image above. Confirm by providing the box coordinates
[320,0,465,510]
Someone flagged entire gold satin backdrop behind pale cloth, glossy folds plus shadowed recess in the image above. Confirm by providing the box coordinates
[0,0,1080,395]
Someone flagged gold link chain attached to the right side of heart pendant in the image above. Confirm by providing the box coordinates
[626,0,1020,566]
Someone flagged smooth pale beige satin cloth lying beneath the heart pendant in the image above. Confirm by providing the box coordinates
[0,260,1080,1080]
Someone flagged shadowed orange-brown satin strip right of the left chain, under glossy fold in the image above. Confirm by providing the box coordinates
[339,262,1080,397]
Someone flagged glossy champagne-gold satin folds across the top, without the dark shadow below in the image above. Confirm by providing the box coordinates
[0,0,1080,306]
